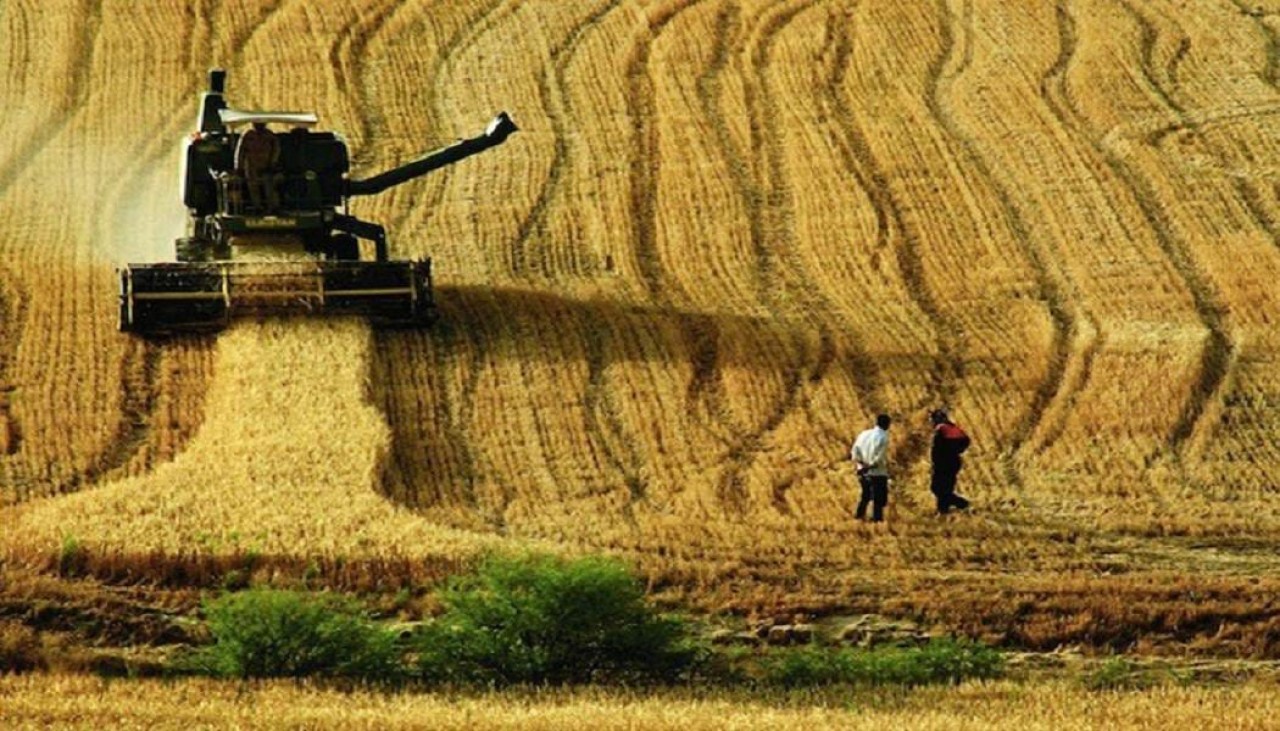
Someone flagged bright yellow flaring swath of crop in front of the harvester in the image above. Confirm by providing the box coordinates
[10,320,501,557]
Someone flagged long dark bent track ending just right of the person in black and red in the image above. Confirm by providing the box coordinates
[924,0,1080,497]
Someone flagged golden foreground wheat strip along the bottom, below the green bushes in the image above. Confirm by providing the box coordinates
[0,676,1280,731]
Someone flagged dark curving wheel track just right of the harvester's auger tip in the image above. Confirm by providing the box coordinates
[511,0,622,279]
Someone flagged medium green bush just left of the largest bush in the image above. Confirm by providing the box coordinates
[188,589,399,681]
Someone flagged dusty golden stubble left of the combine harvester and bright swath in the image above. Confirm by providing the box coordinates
[0,1,280,503]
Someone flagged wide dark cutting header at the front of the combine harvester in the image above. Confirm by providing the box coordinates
[120,261,434,333]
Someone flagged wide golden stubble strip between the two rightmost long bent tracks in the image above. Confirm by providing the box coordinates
[946,3,1211,509]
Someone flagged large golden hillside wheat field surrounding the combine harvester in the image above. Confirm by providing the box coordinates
[0,0,1280,640]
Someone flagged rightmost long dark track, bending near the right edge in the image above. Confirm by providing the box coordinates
[1050,0,1235,456]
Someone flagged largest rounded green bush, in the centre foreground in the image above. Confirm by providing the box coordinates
[413,556,698,685]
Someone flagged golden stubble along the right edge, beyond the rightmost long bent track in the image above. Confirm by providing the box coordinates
[1103,3,1280,530]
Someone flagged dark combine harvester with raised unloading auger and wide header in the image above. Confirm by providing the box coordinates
[119,69,516,334]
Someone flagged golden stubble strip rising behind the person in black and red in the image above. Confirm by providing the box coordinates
[829,0,1062,494]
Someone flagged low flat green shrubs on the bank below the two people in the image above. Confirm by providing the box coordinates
[760,639,1004,687]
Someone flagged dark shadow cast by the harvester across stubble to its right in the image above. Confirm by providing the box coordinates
[372,287,928,526]
